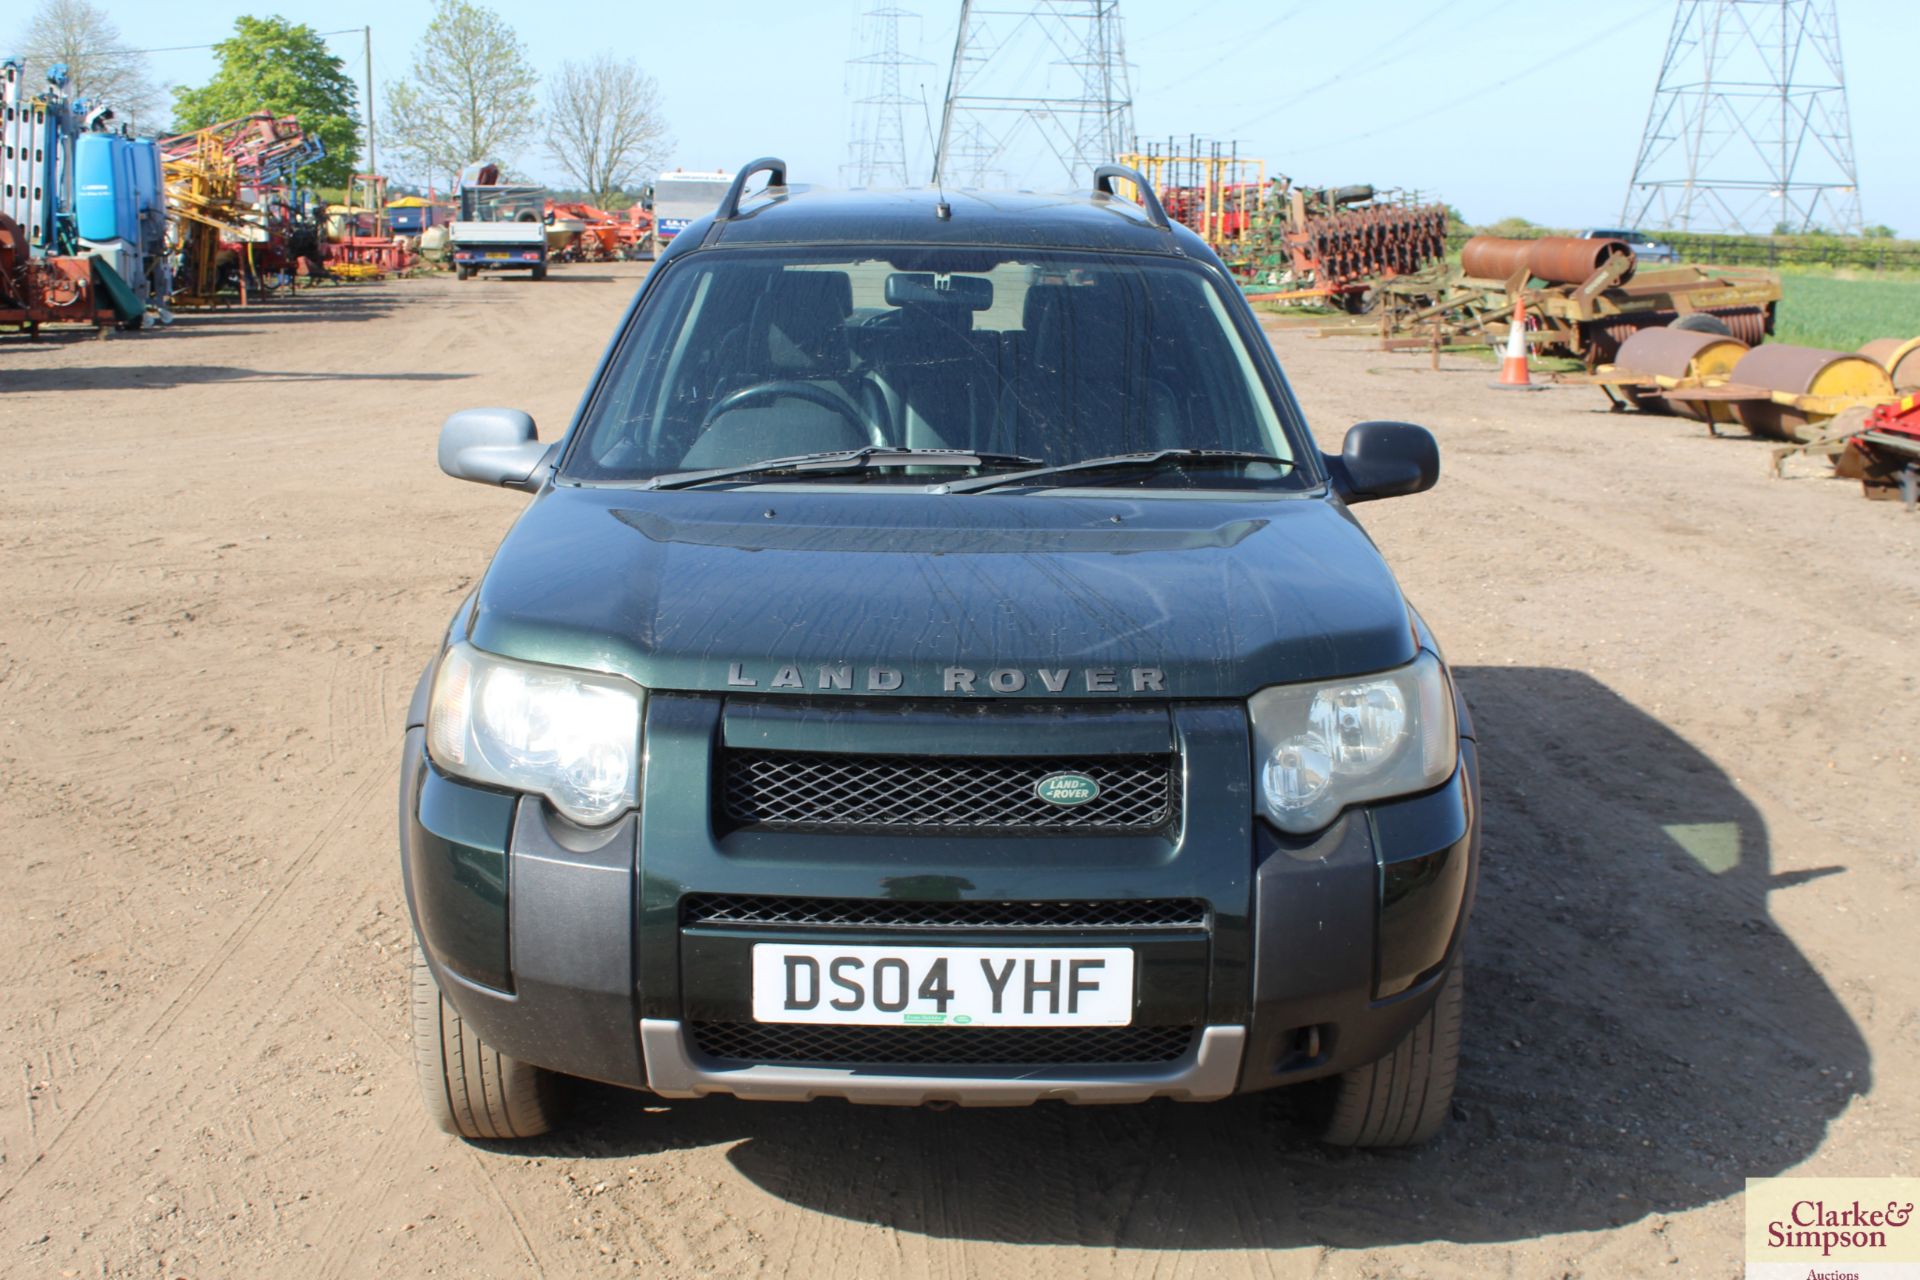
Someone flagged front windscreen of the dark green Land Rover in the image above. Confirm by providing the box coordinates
[561,248,1311,489]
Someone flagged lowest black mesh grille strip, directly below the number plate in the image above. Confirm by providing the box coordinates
[693,1023,1194,1067]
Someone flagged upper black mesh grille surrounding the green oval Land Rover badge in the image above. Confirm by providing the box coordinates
[722,750,1175,831]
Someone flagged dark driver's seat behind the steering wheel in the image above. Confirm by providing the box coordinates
[680,269,883,470]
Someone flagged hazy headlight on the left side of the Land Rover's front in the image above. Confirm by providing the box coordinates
[426,641,647,825]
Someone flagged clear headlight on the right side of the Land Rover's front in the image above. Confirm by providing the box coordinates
[1248,652,1459,835]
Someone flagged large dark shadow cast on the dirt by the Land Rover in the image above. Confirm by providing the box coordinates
[491,668,1870,1249]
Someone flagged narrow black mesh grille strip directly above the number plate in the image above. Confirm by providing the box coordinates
[682,894,1208,931]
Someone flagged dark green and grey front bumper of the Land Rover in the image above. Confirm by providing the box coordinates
[401,693,1478,1105]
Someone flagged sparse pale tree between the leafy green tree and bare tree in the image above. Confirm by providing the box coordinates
[380,0,540,186]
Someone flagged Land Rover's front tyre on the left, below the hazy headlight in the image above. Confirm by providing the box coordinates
[409,944,559,1140]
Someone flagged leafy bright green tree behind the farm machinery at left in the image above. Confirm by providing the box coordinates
[173,17,361,186]
